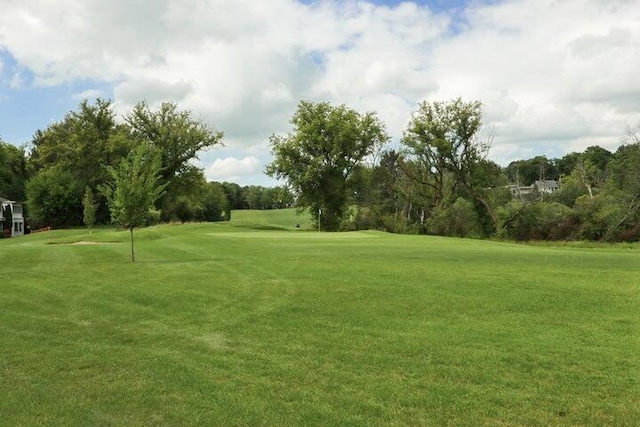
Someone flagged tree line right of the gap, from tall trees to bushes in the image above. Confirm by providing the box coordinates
[266,99,640,241]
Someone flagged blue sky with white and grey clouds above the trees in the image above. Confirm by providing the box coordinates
[0,0,640,186]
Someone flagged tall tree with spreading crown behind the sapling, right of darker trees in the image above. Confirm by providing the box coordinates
[126,102,223,220]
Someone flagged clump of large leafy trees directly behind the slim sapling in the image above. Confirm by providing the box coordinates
[21,99,225,226]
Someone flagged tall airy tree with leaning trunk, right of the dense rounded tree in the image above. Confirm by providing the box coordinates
[402,98,500,234]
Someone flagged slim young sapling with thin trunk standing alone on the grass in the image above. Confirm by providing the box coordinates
[101,144,166,262]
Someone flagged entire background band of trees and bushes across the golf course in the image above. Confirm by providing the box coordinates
[0,99,640,241]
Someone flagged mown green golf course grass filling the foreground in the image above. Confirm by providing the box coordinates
[0,226,640,426]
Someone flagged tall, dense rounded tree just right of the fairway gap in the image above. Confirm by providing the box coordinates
[266,101,389,231]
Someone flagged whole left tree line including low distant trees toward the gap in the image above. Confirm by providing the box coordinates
[0,99,294,232]
